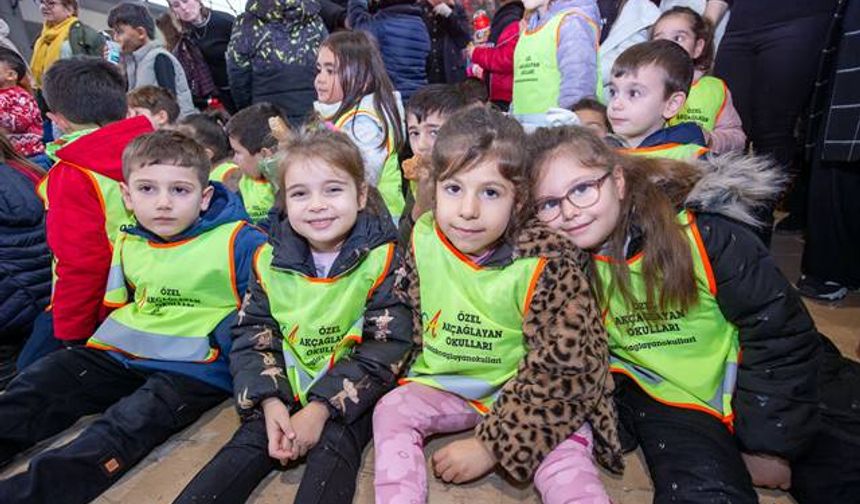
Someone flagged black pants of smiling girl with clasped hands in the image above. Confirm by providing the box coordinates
[174,410,373,504]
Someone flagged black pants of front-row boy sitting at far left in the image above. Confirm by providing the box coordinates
[0,348,228,504]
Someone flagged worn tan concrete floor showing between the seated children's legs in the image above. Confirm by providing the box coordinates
[0,236,860,504]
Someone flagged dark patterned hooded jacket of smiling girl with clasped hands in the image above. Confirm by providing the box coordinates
[230,207,412,424]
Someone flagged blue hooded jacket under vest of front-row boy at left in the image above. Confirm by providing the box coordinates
[99,182,266,392]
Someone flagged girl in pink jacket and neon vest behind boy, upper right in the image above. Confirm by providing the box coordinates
[651,7,747,154]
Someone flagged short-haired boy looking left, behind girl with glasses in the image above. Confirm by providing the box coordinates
[607,40,708,159]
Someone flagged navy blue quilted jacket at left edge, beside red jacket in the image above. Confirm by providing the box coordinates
[0,163,51,344]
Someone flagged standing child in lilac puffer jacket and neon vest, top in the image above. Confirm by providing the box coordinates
[511,0,603,117]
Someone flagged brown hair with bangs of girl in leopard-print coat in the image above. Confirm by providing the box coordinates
[430,106,528,238]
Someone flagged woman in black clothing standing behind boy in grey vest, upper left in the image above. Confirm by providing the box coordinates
[170,0,236,113]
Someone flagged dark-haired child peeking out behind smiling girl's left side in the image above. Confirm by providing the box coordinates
[227,102,285,222]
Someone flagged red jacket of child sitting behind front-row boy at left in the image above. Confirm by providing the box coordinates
[46,116,153,340]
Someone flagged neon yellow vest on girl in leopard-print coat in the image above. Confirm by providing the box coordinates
[404,213,545,413]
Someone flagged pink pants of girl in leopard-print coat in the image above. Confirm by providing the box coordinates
[373,383,609,504]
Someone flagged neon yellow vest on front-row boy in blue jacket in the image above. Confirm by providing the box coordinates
[87,221,245,362]
